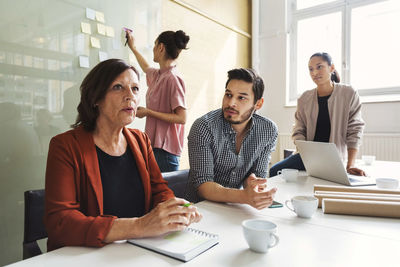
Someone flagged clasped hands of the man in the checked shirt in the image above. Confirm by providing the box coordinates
[244,173,277,210]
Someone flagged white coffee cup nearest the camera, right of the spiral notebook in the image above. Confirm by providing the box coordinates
[242,219,279,253]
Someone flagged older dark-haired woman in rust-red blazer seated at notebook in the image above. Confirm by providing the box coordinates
[44,59,201,250]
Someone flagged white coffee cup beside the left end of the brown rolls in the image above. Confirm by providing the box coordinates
[285,196,318,218]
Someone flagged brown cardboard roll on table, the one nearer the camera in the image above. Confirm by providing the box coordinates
[322,198,400,218]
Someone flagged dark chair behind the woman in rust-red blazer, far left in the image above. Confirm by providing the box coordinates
[22,189,47,260]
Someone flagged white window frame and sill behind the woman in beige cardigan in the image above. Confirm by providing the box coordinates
[286,0,400,106]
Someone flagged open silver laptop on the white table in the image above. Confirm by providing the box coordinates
[295,140,376,186]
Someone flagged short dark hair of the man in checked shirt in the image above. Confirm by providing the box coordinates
[225,68,264,104]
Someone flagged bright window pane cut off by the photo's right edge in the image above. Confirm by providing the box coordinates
[350,0,400,89]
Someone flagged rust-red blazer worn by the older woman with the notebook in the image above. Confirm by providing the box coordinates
[44,127,174,251]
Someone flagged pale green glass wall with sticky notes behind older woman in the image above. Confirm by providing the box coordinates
[0,0,161,265]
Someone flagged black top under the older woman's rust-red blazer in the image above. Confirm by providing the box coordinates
[96,146,145,218]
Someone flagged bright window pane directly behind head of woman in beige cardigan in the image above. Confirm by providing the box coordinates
[296,12,342,95]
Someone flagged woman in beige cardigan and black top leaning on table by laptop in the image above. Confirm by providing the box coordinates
[270,53,365,177]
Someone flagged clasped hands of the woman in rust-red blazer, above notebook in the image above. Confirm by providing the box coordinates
[137,198,201,237]
